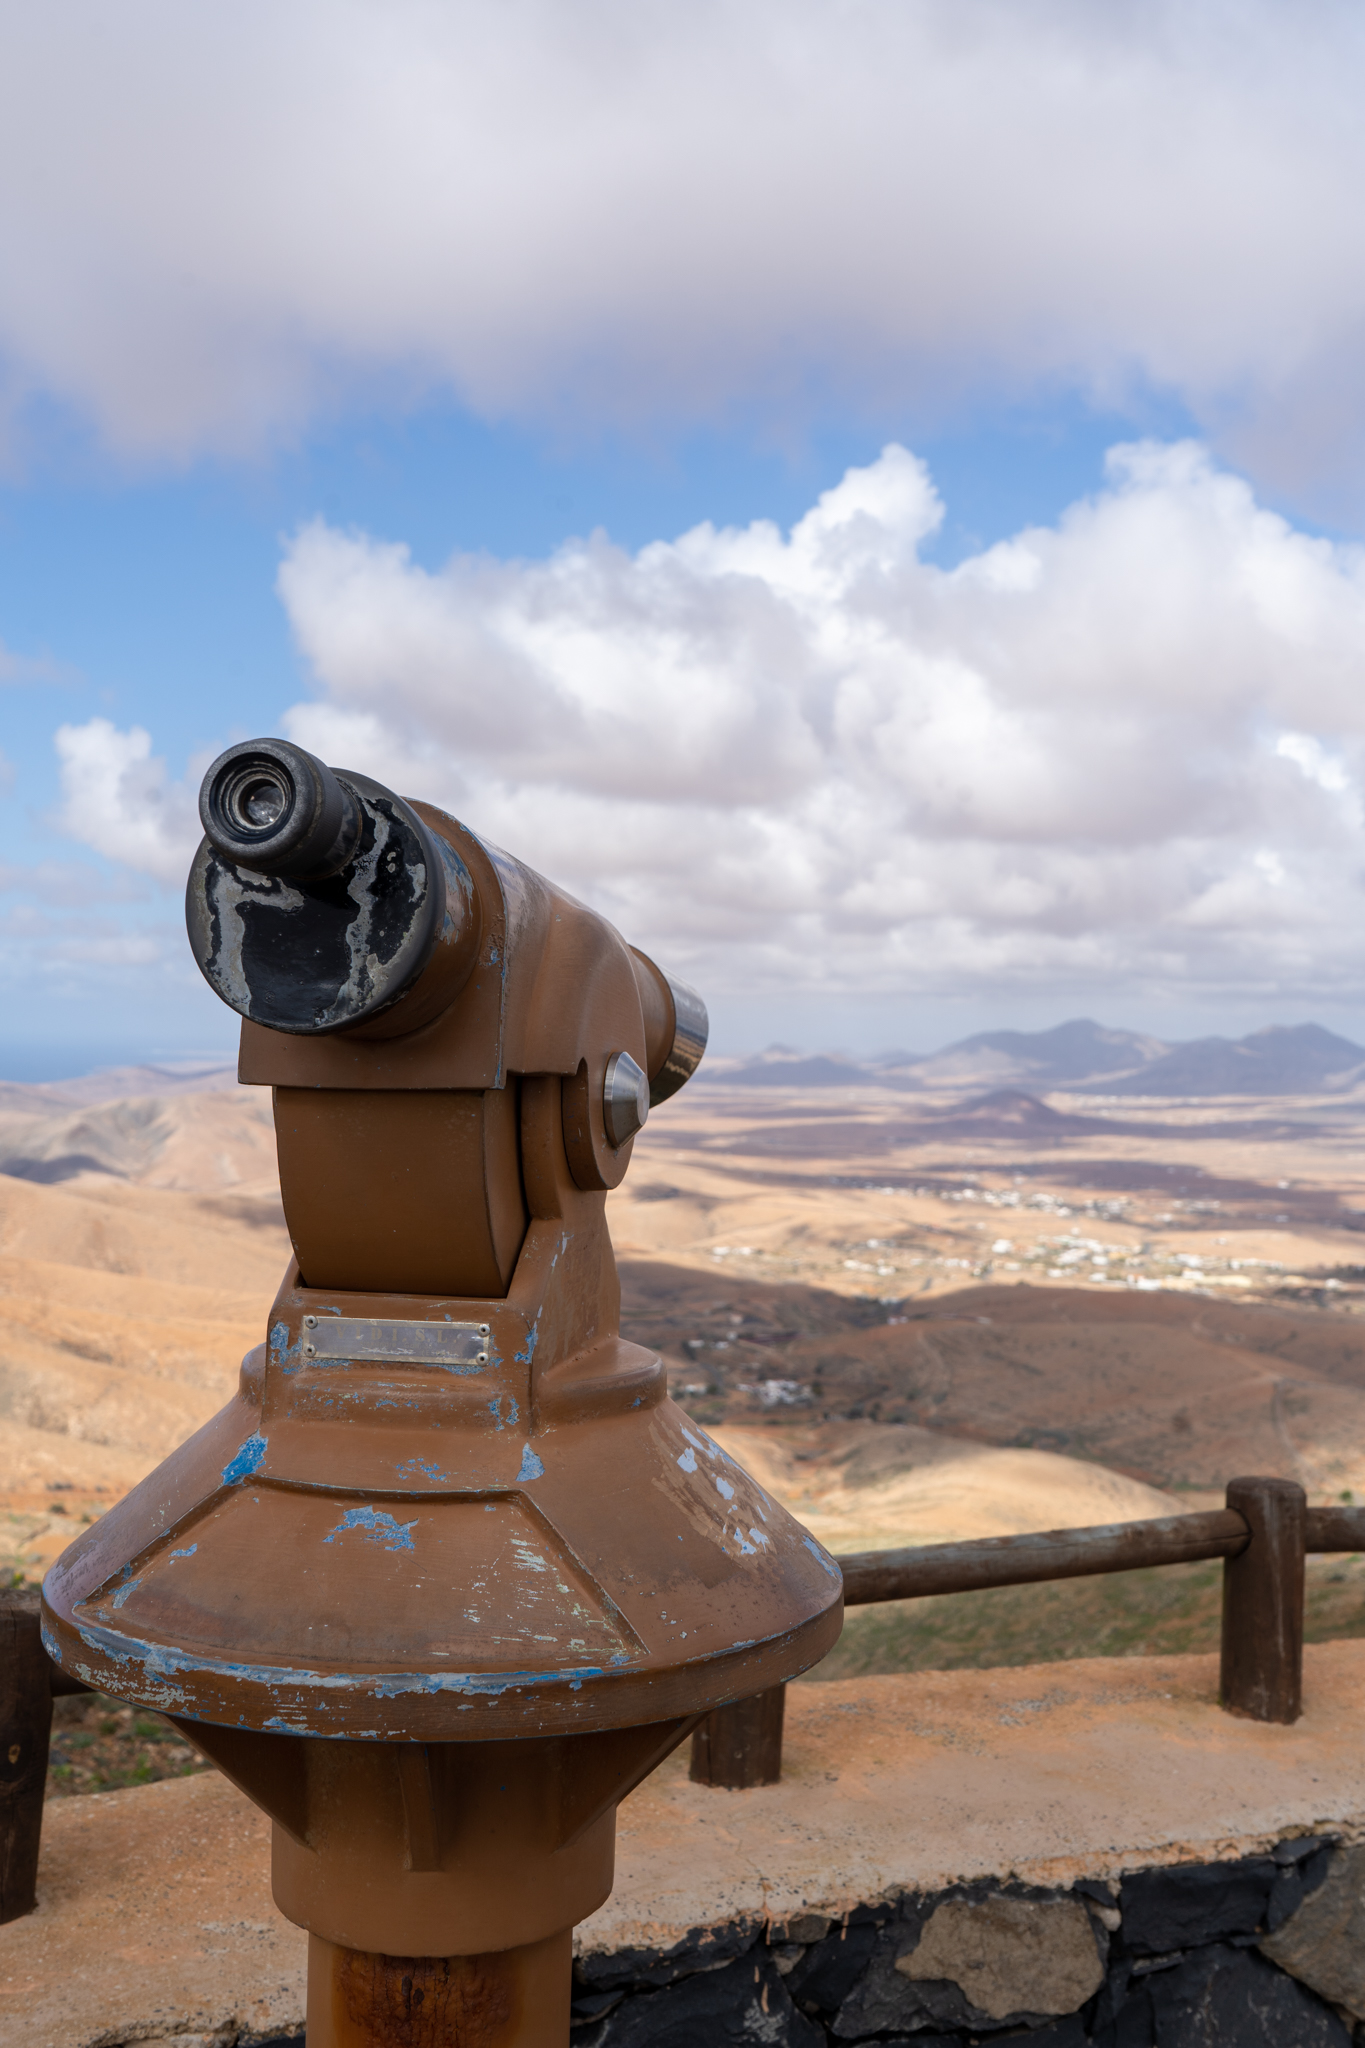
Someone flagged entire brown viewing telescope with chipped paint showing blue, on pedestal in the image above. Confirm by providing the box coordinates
[43,739,841,2048]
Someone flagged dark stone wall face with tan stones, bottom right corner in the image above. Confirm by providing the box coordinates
[573,1835,1365,2048]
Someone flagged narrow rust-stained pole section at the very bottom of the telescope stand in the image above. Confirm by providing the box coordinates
[307,1927,573,2048]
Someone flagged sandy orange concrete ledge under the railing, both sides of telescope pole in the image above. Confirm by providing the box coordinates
[0,1642,1365,2048]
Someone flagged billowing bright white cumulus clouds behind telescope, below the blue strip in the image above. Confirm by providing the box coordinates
[59,444,1365,1004]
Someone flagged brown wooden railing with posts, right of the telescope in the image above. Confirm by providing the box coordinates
[692,1479,1365,1790]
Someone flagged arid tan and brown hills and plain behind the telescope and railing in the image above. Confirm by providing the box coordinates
[0,1026,1365,1769]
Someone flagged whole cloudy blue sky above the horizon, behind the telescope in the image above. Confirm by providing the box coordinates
[0,0,1365,1079]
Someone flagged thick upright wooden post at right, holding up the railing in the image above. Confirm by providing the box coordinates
[1220,1479,1308,1720]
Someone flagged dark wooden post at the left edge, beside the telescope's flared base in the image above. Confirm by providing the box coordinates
[0,1587,51,1923]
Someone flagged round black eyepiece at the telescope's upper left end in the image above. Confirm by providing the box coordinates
[199,739,362,881]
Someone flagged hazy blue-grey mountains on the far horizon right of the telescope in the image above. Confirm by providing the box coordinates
[710,1018,1365,1098]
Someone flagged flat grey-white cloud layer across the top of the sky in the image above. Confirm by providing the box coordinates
[0,0,1365,497]
